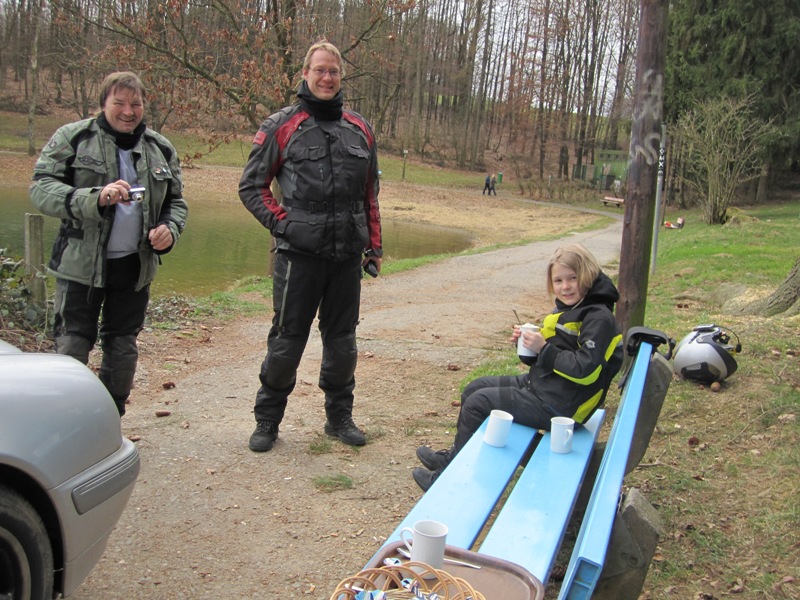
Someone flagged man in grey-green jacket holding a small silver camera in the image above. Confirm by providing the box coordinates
[30,72,188,416]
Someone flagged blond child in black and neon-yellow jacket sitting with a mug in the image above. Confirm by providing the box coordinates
[413,244,623,491]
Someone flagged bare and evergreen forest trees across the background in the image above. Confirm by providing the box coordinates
[0,0,800,197]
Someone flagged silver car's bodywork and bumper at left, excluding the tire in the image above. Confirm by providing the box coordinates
[0,341,140,596]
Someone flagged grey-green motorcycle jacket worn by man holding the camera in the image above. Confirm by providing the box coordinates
[29,118,188,290]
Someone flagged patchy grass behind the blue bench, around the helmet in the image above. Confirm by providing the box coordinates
[626,203,800,598]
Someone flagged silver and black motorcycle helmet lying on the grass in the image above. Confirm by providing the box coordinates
[673,325,742,383]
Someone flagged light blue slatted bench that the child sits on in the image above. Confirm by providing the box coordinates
[368,327,674,599]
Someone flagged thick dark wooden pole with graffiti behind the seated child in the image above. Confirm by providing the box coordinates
[617,0,669,331]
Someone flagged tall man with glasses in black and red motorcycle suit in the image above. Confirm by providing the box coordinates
[239,42,383,452]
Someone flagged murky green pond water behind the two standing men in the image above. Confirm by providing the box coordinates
[0,187,470,296]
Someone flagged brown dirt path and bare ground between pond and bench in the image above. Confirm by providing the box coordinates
[3,156,622,600]
